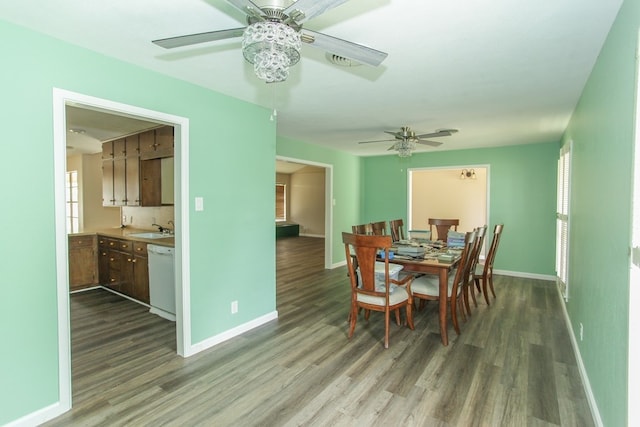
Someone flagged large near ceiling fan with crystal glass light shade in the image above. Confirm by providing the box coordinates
[153,0,387,83]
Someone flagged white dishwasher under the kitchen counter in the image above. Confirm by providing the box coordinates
[147,245,176,321]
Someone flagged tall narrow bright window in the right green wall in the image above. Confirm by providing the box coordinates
[556,142,571,301]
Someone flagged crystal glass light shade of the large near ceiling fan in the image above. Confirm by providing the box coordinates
[242,21,302,83]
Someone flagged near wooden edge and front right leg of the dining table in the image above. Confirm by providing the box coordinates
[389,252,460,345]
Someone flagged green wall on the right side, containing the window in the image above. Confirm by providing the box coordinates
[565,0,640,426]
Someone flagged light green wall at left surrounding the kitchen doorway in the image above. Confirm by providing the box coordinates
[0,21,276,425]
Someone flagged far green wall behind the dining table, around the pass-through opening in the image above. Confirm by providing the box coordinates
[360,143,559,275]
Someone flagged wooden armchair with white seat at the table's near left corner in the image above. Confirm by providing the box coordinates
[342,233,414,348]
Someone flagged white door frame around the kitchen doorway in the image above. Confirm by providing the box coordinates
[53,88,191,412]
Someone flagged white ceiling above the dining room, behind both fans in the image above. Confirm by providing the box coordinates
[0,0,622,155]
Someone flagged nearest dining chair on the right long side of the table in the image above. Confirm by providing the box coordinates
[411,231,477,335]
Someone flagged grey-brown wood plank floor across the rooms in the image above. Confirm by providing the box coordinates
[46,237,593,427]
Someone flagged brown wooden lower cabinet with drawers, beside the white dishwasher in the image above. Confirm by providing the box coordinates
[98,236,149,304]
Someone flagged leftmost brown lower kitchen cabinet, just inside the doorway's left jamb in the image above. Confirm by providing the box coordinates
[69,235,98,291]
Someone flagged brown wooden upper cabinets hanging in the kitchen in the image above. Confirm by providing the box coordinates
[102,126,173,206]
